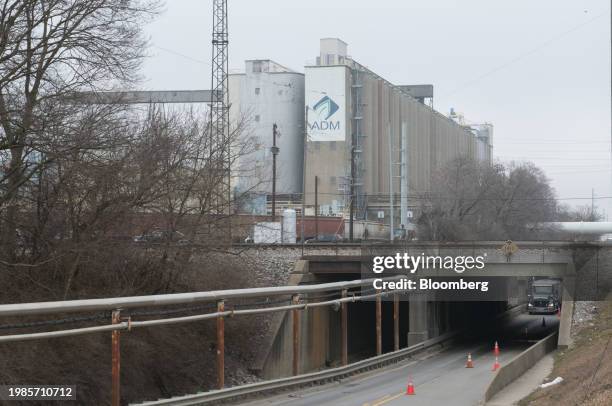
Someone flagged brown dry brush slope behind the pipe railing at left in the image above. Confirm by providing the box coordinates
[0,247,282,406]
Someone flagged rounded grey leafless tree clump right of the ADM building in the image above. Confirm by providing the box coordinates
[418,158,557,240]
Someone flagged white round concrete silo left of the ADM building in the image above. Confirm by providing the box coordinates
[229,60,304,214]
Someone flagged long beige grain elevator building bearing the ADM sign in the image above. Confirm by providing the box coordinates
[305,38,492,225]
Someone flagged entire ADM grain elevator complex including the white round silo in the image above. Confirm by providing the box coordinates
[230,38,493,232]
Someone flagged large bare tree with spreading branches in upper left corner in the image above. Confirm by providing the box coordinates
[0,0,158,258]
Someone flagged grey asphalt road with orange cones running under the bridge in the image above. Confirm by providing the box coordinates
[243,314,559,406]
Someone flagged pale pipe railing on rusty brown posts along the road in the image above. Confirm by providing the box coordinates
[0,277,402,406]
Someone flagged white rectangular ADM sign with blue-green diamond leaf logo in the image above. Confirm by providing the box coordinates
[306,66,346,142]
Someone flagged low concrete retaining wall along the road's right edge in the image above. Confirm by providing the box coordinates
[485,332,558,402]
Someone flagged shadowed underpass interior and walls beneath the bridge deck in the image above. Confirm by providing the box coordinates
[263,275,559,379]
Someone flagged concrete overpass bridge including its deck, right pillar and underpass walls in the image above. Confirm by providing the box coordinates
[255,242,588,378]
